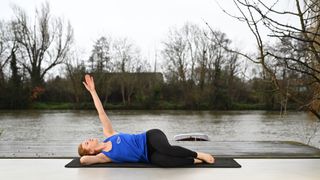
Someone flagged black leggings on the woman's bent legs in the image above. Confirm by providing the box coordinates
[147,129,197,167]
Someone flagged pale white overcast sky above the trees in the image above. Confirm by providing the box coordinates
[0,0,294,76]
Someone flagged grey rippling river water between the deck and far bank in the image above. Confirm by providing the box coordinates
[0,110,320,148]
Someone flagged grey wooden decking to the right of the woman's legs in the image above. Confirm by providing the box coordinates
[176,141,320,158]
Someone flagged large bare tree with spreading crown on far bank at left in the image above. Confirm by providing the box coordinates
[11,3,73,87]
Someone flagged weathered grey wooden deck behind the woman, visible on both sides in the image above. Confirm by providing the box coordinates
[0,141,320,158]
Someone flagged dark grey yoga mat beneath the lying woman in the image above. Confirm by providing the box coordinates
[65,157,241,168]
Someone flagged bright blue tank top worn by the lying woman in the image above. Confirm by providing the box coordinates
[102,132,149,163]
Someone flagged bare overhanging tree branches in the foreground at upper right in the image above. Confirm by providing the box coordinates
[216,0,320,119]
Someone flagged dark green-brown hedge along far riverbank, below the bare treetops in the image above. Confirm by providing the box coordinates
[0,68,294,110]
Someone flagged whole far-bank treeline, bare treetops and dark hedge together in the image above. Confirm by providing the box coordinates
[0,4,311,110]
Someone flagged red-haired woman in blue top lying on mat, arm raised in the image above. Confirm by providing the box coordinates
[78,75,214,167]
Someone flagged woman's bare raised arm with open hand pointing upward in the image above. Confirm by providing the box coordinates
[83,74,116,137]
